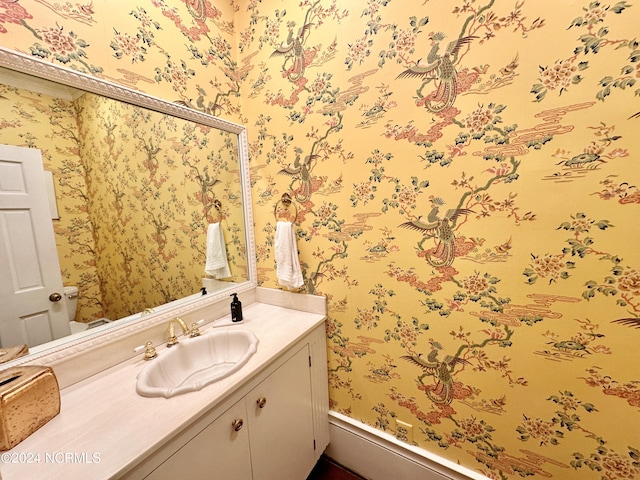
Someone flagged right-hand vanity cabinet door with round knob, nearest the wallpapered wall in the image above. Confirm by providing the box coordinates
[246,346,315,480]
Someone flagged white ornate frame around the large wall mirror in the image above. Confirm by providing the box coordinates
[0,47,257,368]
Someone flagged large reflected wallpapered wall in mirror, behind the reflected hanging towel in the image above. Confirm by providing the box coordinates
[73,95,246,319]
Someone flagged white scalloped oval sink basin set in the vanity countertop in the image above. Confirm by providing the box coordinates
[136,327,258,398]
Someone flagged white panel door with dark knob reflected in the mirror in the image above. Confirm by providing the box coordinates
[0,145,70,347]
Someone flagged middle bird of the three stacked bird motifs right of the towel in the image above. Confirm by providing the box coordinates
[400,198,473,268]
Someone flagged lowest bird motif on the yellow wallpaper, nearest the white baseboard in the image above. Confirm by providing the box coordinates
[400,343,469,405]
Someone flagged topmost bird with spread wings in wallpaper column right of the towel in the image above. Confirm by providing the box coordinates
[396,32,477,113]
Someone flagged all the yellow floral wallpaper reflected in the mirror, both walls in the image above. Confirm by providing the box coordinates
[0,85,246,321]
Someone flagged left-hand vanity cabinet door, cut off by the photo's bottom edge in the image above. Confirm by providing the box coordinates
[146,400,251,480]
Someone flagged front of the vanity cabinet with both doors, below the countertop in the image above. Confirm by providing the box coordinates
[139,345,324,480]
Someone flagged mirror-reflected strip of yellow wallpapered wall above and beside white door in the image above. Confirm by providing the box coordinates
[0,82,104,321]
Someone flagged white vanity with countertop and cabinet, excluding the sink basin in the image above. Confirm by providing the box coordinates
[0,300,329,480]
